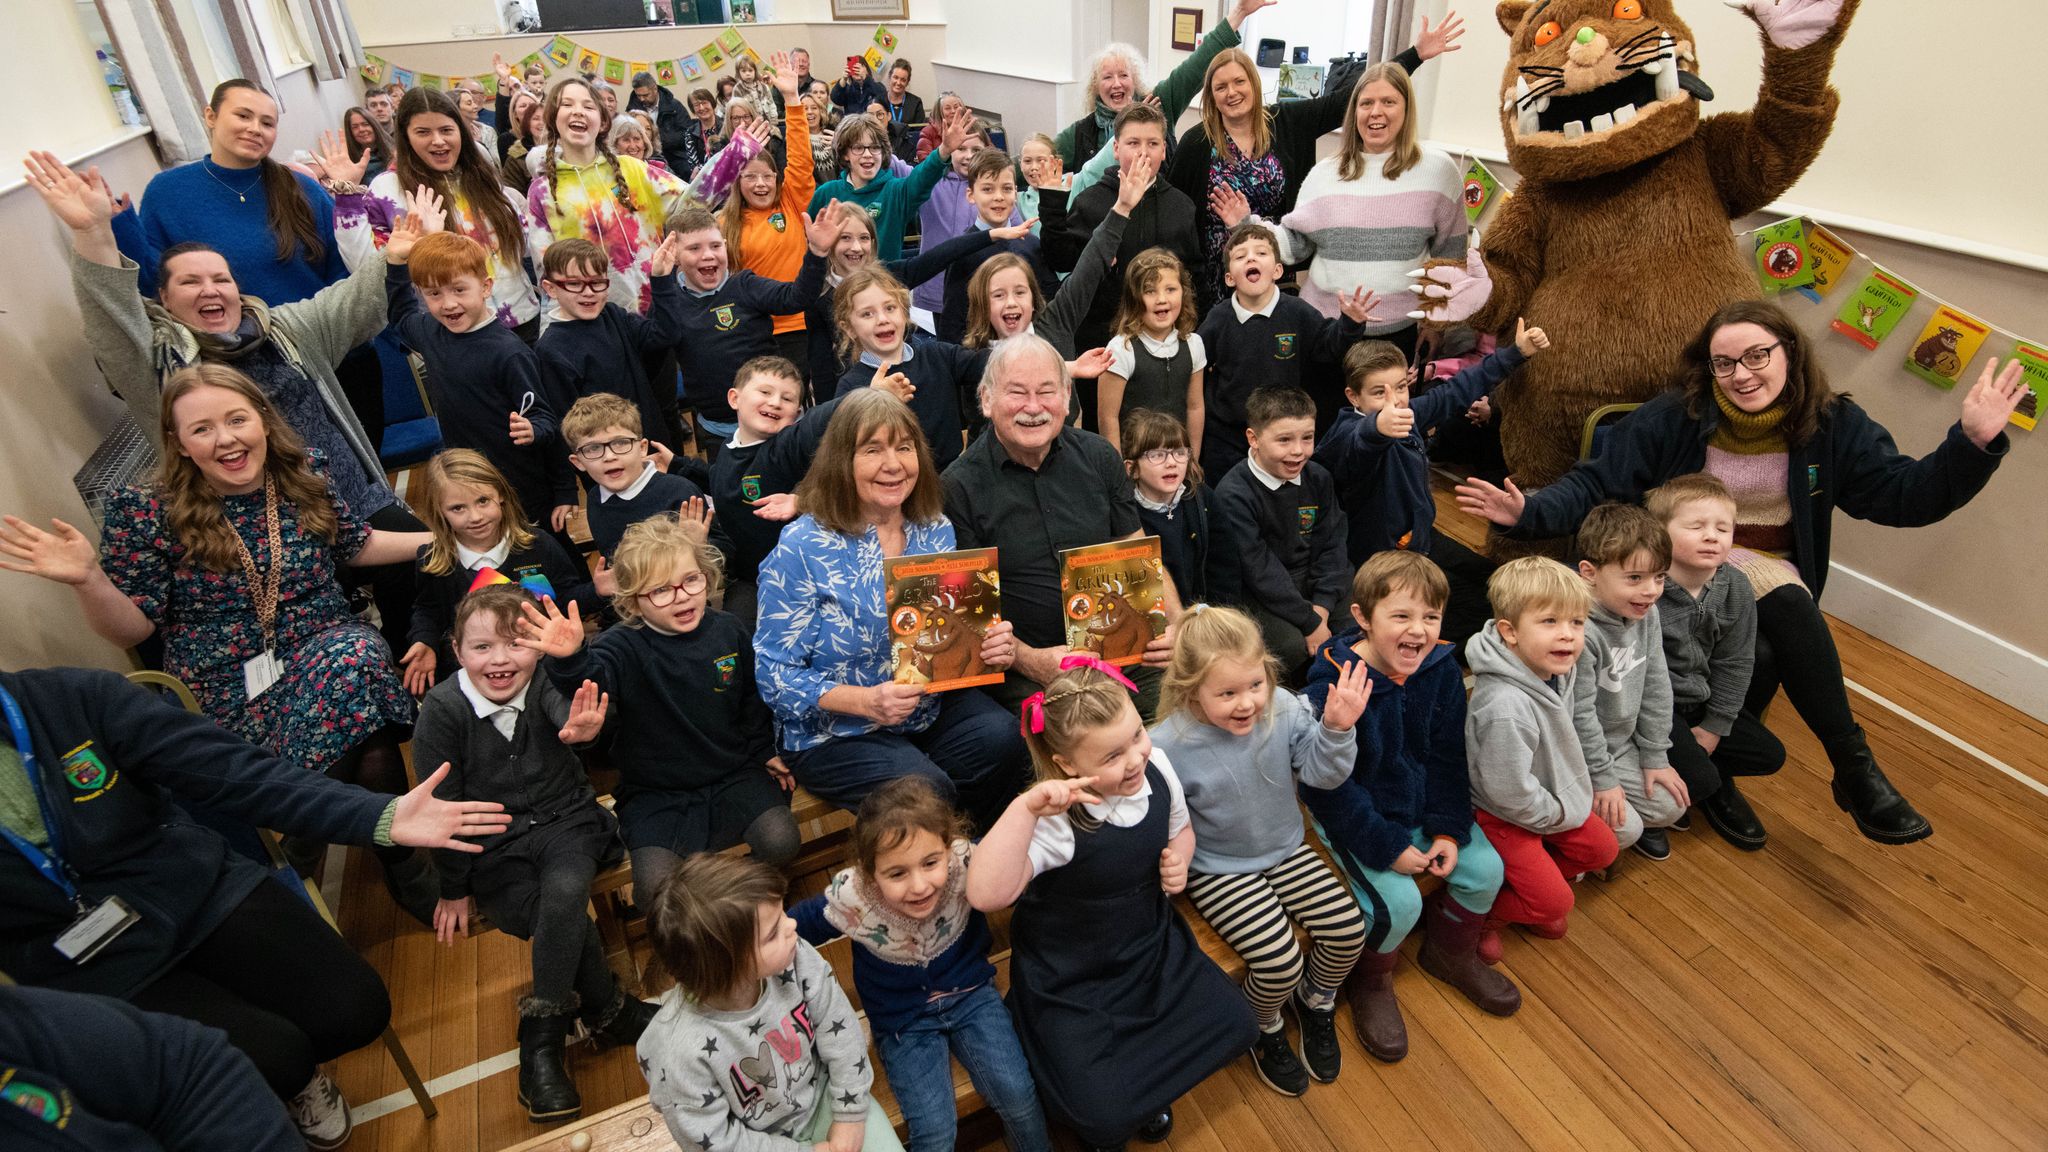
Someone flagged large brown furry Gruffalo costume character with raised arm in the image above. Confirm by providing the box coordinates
[1425,0,1858,486]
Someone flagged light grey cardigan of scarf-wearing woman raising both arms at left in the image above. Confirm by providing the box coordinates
[72,243,385,488]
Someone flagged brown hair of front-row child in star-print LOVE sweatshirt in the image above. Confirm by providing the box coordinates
[643,853,788,1002]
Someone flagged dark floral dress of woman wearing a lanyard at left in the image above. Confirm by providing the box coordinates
[100,463,414,771]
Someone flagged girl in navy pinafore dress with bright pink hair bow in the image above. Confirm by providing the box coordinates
[967,654,1260,1148]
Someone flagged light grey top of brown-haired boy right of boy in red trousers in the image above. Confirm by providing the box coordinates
[1571,603,1671,791]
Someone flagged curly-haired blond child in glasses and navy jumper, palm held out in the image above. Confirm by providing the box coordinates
[520,517,803,892]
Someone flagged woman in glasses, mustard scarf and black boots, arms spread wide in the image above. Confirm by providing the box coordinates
[1458,299,2028,851]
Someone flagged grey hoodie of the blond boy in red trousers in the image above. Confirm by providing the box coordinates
[1464,619,1593,836]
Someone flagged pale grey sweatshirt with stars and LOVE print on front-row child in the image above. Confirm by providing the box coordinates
[639,941,874,1152]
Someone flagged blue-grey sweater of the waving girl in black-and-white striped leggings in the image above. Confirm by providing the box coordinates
[1151,687,1358,875]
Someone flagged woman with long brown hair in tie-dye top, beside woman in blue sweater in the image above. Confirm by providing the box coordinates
[322,88,541,344]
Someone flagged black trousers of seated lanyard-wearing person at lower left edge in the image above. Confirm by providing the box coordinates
[129,879,391,1101]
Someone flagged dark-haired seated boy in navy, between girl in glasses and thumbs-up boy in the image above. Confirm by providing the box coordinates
[1204,387,1352,685]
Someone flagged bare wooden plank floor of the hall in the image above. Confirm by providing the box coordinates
[336,487,2048,1152]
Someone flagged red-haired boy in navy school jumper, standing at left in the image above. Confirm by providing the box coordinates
[385,231,575,541]
